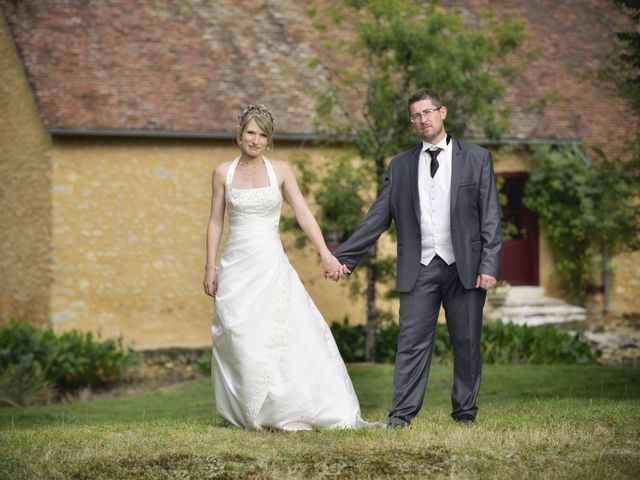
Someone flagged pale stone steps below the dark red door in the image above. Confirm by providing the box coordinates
[487,287,587,326]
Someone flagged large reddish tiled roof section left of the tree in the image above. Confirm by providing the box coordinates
[2,0,318,133]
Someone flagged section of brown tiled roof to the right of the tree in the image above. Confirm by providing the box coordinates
[452,0,637,149]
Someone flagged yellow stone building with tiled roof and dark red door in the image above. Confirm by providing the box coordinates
[0,0,640,348]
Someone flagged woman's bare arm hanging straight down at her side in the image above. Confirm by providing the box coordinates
[202,164,228,297]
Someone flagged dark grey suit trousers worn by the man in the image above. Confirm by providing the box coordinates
[388,256,487,425]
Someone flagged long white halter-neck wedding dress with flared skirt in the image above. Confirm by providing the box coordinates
[212,158,374,430]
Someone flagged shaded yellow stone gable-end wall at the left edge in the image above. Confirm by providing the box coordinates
[0,14,52,324]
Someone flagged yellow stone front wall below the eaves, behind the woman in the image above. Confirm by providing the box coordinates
[51,137,396,348]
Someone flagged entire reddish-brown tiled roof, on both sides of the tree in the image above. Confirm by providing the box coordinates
[0,0,632,148]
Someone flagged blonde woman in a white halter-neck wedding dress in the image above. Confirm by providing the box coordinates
[203,105,372,430]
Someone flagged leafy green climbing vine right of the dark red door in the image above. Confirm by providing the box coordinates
[524,145,640,304]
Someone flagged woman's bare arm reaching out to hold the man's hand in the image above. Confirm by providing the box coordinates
[278,162,350,279]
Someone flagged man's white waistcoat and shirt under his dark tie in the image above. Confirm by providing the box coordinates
[418,137,456,265]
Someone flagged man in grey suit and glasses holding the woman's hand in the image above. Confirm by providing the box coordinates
[325,89,501,427]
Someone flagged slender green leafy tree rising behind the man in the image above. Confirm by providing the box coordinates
[300,0,524,361]
